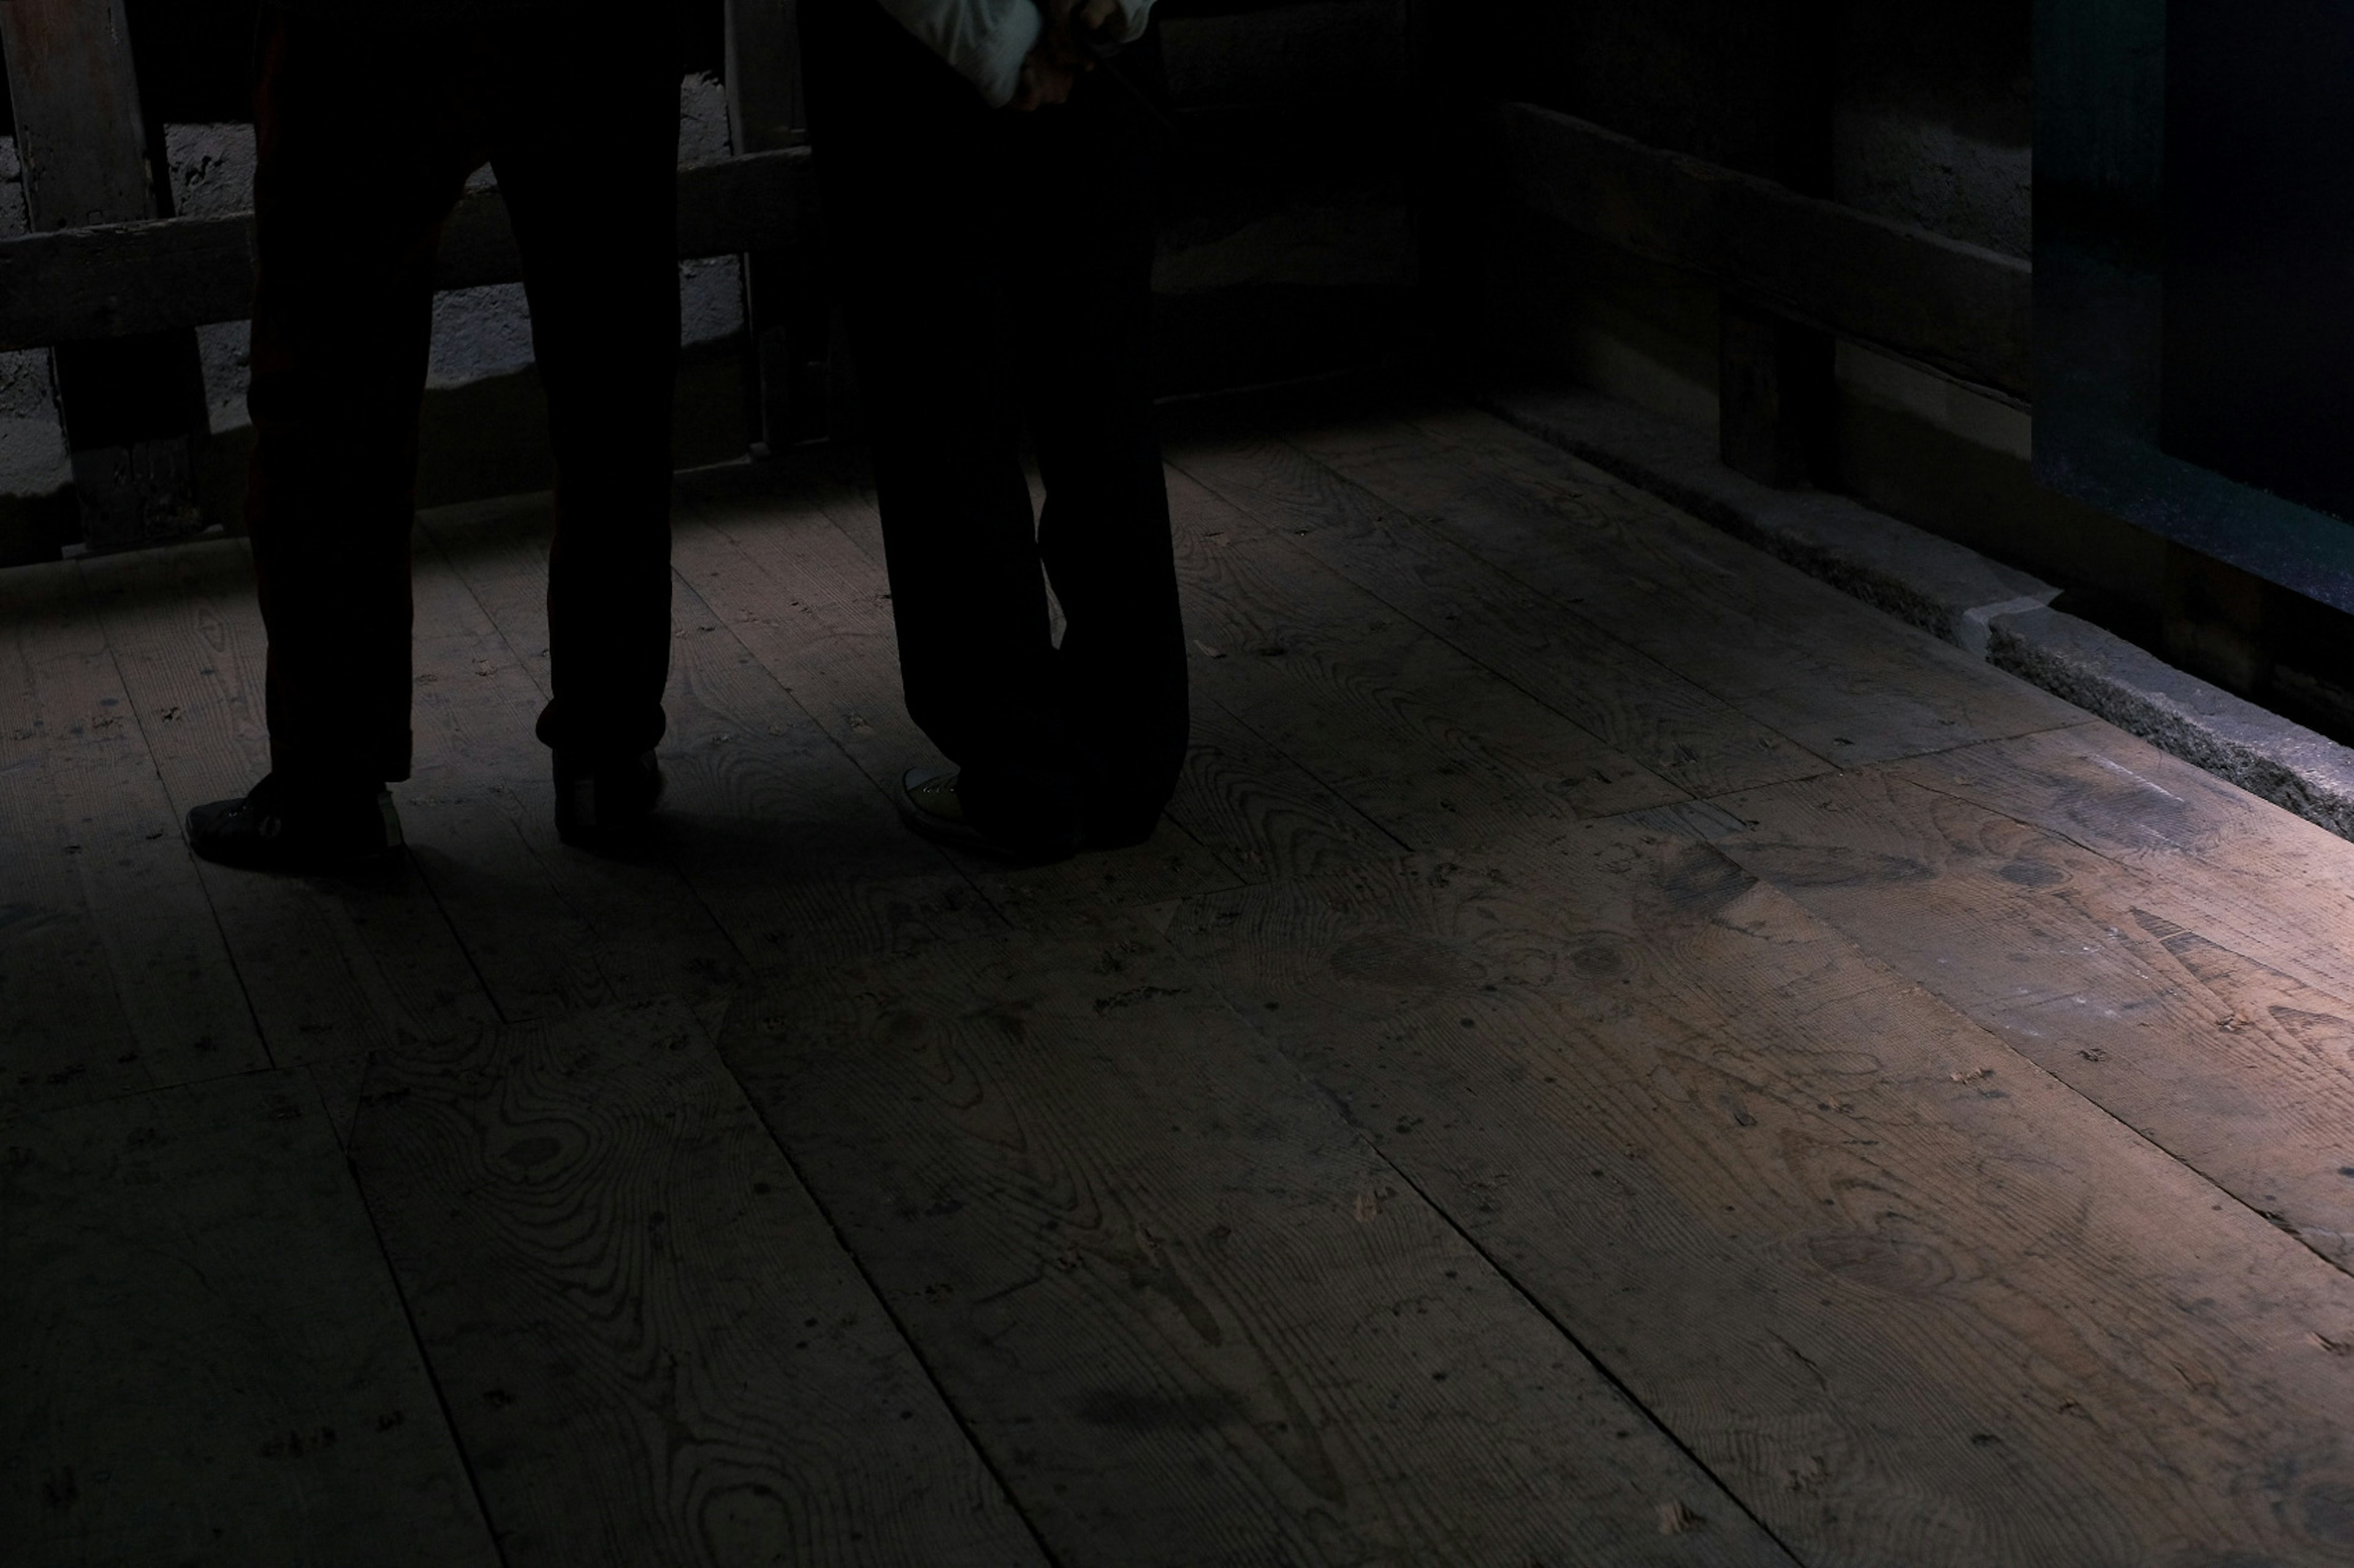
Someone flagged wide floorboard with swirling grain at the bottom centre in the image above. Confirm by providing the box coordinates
[723,911,1787,1568]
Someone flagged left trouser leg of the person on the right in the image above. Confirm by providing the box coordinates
[802,0,1081,843]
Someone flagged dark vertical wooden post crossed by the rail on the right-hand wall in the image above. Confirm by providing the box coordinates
[1716,0,1838,487]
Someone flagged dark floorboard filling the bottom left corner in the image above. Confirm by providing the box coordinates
[0,1071,501,1568]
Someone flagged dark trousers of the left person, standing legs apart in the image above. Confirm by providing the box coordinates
[245,5,678,784]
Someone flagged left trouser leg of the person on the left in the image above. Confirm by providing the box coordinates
[247,9,480,784]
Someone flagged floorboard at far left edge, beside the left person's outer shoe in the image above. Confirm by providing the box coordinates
[0,565,269,1106]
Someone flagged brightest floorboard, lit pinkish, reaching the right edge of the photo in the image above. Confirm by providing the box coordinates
[1709,730,2354,1266]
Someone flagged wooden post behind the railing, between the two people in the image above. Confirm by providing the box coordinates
[725,0,831,450]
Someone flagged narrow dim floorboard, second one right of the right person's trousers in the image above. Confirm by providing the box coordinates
[1175,424,1829,793]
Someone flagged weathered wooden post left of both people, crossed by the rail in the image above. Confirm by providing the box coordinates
[0,0,205,549]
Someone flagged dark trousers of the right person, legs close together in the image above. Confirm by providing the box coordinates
[801,0,1186,845]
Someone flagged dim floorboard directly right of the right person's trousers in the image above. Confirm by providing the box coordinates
[1170,473,1683,848]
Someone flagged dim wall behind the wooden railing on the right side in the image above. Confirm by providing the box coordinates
[1450,0,2168,619]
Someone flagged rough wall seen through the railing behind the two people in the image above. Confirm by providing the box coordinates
[0,0,1417,563]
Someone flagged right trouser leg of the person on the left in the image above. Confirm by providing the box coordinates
[492,7,678,761]
